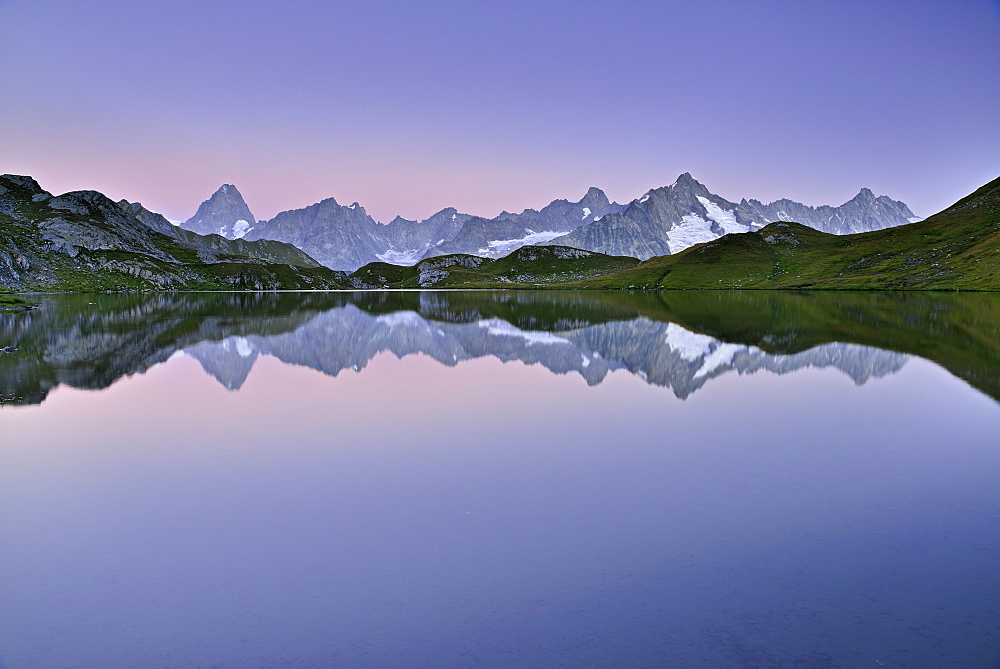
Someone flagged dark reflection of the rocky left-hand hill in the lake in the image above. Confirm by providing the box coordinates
[0,292,356,406]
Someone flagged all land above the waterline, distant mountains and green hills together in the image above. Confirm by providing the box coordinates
[0,174,1000,292]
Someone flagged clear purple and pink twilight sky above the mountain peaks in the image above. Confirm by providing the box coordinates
[0,0,1000,222]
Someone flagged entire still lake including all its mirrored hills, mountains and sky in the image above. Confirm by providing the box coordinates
[0,291,1000,668]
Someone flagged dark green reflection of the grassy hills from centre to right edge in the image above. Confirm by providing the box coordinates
[345,290,1000,399]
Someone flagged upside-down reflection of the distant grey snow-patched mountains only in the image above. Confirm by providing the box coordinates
[185,305,909,398]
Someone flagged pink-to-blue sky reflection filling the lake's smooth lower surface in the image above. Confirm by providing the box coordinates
[0,348,1000,666]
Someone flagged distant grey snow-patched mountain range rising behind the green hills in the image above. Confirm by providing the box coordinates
[181,173,920,272]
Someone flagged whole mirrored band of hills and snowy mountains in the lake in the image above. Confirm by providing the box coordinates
[0,291,1000,404]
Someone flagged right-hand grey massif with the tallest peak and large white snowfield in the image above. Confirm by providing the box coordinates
[549,173,918,260]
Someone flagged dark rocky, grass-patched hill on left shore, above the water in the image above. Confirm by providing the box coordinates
[0,174,347,290]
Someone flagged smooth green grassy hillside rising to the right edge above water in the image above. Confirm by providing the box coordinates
[574,179,1000,290]
